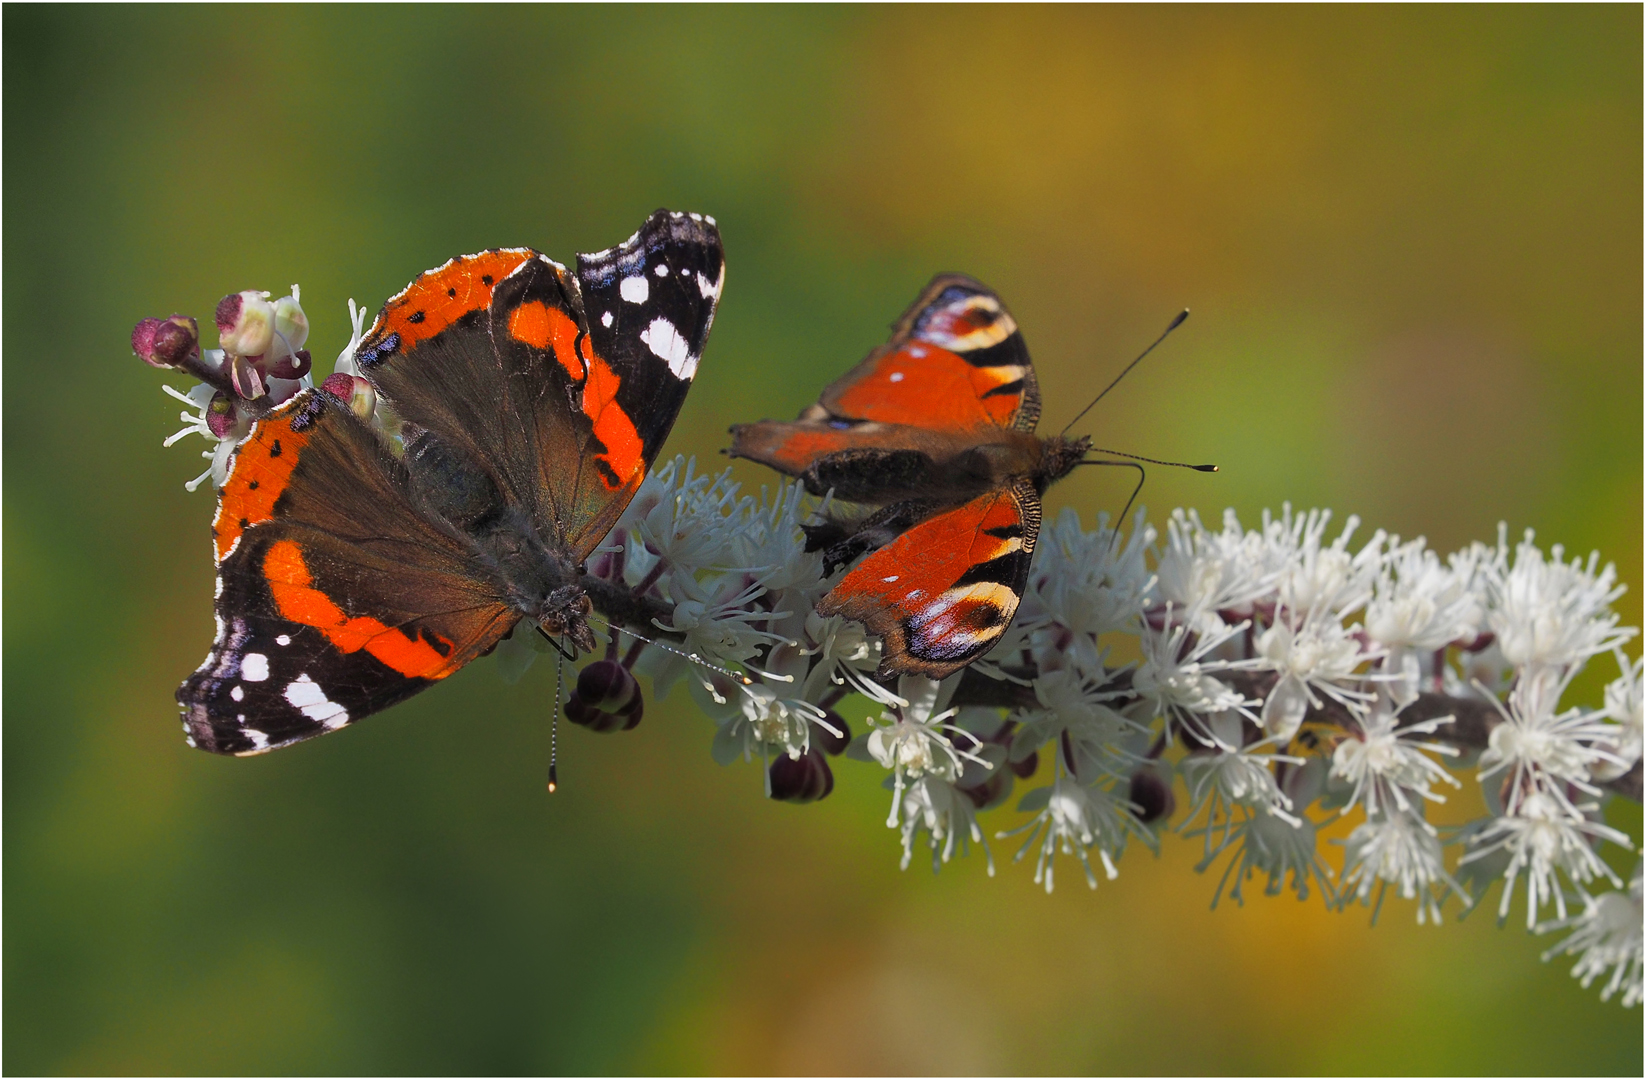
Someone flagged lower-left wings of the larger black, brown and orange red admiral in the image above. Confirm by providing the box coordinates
[178,390,518,754]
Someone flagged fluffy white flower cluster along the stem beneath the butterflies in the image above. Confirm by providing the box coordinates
[156,306,1643,1006]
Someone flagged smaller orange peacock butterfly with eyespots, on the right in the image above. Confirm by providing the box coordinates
[729,275,1091,678]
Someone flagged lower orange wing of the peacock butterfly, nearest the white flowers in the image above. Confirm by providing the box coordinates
[818,481,1040,678]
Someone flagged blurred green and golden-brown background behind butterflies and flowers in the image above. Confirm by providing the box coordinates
[3,5,1643,1075]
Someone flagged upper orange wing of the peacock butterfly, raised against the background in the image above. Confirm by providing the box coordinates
[731,273,1040,476]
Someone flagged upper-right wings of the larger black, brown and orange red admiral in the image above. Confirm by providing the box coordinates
[356,211,724,560]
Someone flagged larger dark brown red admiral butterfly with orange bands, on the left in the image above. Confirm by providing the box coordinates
[178,211,724,754]
